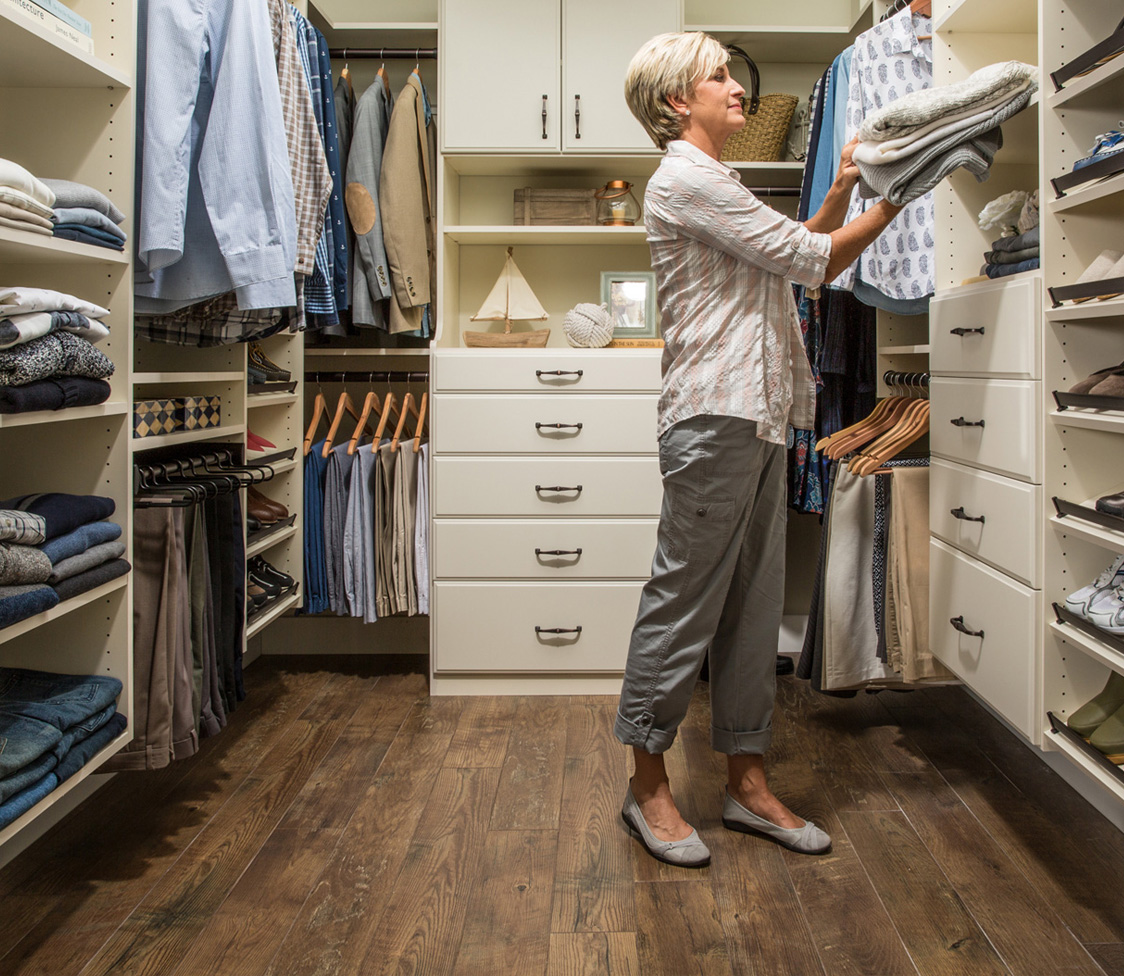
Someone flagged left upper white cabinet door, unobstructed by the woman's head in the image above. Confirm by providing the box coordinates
[437,0,559,152]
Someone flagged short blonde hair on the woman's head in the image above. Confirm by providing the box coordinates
[625,30,729,150]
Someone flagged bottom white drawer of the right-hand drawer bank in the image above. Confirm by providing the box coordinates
[930,540,1039,739]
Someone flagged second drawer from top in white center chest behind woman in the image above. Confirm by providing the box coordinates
[433,394,659,454]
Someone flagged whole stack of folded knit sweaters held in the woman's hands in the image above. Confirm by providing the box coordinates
[853,61,1039,206]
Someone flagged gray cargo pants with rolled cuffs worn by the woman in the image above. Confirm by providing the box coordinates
[614,415,787,756]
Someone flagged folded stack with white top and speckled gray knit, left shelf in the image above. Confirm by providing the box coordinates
[0,286,114,414]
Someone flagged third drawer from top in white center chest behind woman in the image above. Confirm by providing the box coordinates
[430,457,663,518]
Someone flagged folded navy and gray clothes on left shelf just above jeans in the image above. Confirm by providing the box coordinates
[0,492,132,627]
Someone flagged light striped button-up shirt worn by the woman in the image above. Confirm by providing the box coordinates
[644,139,832,444]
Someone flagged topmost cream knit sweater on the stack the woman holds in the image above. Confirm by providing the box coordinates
[859,61,1039,142]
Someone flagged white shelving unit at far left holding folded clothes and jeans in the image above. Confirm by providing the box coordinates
[0,0,136,860]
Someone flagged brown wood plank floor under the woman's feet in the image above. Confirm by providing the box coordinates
[0,658,1124,976]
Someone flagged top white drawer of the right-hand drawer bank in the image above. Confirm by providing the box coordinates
[930,278,1042,379]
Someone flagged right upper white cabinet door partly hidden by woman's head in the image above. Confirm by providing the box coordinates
[561,0,682,153]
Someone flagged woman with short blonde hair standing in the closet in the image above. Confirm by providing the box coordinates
[614,33,900,867]
